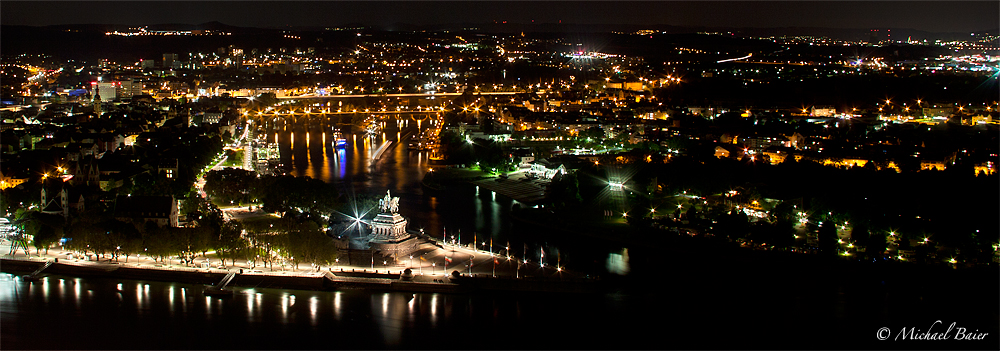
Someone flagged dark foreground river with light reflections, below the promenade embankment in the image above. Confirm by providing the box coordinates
[0,268,998,350]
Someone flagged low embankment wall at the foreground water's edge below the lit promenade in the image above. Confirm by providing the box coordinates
[0,258,602,293]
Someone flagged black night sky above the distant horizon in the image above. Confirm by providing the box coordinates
[0,0,1000,32]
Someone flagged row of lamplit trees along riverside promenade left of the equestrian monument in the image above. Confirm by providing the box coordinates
[32,209,338,268]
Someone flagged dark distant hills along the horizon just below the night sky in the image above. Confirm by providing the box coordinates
[0,21,1000,60]
